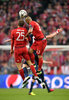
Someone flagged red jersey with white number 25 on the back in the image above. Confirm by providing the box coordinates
[11,27,27,48]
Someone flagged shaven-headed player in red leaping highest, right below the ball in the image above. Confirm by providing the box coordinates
[25,16,62,73]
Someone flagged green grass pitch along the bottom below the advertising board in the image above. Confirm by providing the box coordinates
[0,89,69,100]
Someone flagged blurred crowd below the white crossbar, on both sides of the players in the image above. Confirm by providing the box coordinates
[0,50,69,74]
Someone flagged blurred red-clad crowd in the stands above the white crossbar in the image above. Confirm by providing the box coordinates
[0,0,69,45]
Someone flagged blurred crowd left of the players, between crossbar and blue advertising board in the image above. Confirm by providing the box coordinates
[0,50,18,74]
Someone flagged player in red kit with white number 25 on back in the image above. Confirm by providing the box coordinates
[10,19,41,86]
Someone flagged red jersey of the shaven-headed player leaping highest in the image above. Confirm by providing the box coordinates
[29,21,44,40]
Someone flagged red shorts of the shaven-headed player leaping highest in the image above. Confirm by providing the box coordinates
[31,39,47,55]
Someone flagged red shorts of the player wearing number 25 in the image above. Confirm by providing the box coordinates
[14,47,30,63]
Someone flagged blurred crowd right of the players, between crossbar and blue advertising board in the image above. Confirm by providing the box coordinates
[43,51,69,74]
